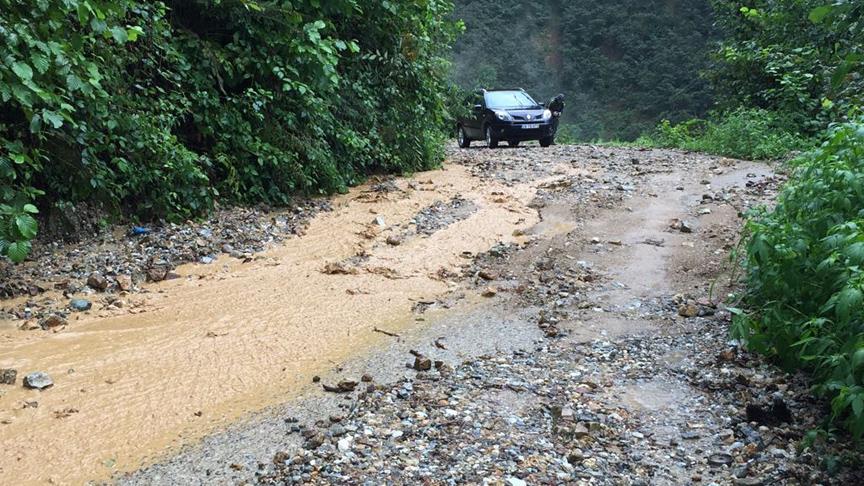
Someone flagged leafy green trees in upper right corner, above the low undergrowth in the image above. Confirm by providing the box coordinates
[709,0,864,134]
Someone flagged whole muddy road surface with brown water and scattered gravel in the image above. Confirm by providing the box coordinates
[0,142,852,485]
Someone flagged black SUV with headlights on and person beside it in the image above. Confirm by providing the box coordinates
[456,89,564,148]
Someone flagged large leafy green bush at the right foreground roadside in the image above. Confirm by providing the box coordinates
[734,118,864,438]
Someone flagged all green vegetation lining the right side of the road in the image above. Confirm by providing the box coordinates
[696,0,864,438]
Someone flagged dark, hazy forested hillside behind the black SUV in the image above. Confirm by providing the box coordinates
[453,0,715,140]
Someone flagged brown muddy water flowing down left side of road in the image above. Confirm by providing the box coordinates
[0,165,580,484]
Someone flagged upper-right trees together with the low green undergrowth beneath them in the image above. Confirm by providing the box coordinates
[641,0,864,159]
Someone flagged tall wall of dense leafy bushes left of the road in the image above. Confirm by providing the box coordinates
[0,0,456,260]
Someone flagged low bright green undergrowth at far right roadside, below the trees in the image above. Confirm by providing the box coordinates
[639,108,814,160]
